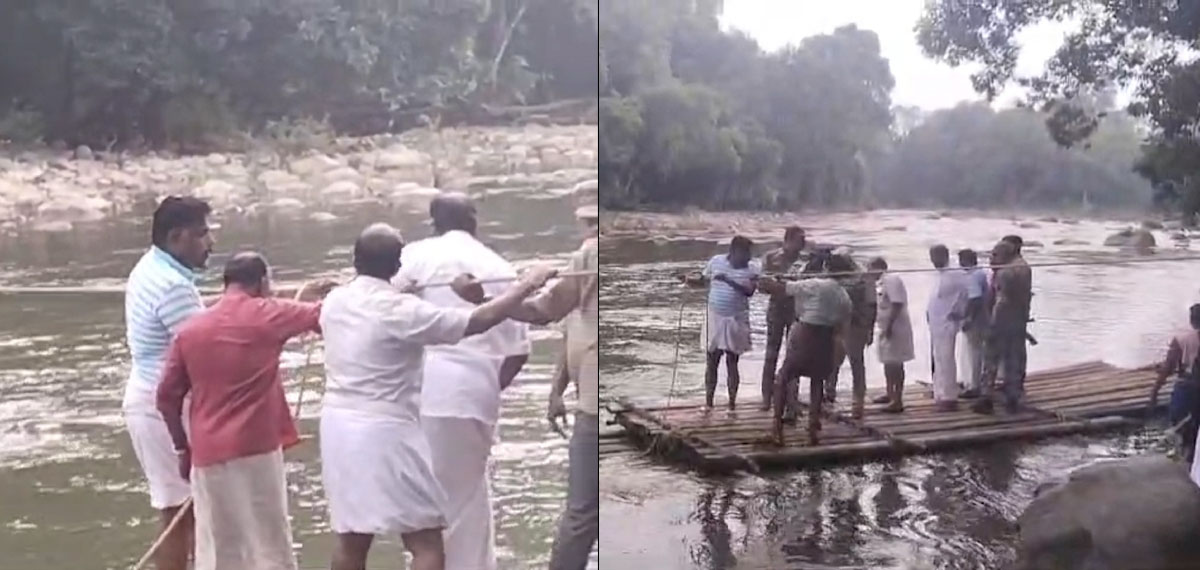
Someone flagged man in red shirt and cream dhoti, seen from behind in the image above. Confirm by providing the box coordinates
[157,253,328,570]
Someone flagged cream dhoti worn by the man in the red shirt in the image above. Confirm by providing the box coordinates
[192,449,296,570]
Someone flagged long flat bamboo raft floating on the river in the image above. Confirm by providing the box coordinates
[610,362,1165,474]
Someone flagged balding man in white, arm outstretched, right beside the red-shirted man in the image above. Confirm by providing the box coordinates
[320,224,554,570]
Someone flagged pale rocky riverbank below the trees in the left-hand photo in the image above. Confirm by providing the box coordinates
[0,125,598,233]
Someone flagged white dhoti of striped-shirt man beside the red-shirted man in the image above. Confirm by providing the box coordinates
[122,390,192,510]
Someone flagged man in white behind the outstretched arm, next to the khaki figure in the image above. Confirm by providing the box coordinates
[396,193,529,570]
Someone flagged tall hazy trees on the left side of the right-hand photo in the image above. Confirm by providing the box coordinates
[600,0,893,208]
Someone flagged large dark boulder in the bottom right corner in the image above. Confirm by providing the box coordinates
[1013,456,1200,570]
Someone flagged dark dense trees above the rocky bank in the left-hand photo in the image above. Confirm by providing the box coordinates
[0,0,599,144]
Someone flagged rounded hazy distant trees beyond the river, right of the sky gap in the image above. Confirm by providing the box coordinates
[876,103,1151,210]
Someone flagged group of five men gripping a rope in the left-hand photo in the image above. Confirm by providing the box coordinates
[122,186,599,570]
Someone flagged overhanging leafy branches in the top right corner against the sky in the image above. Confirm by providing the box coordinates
[917,0,1200,216]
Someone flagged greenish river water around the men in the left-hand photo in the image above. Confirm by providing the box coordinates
[0,193,595,570]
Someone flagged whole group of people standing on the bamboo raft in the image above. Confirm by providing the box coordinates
[684,227,1033,443]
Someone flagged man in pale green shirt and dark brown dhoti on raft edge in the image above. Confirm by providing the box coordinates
[760,254,853,445]
